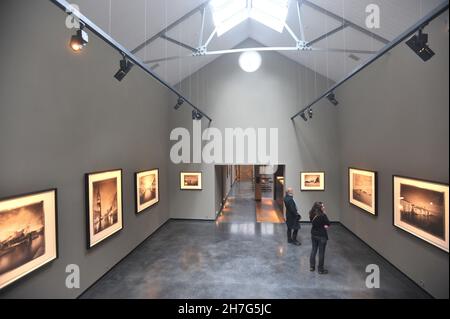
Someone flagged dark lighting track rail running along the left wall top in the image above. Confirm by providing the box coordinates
[50,0,212,122]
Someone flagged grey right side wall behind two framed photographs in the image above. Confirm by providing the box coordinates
[337,11,449,298]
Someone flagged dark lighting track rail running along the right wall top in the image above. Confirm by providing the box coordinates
[291,1,449,120]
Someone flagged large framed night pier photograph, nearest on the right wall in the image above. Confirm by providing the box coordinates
[393,176,449,252]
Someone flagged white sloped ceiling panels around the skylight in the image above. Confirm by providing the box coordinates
[76,0,447,84]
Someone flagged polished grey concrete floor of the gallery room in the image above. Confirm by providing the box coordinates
[82,182,428,299]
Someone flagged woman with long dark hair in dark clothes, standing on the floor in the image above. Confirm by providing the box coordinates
[309,202,330,275]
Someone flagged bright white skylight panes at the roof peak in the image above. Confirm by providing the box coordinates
[210,0,290,37]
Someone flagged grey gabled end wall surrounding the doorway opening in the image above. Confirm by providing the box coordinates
[169,40,340,221]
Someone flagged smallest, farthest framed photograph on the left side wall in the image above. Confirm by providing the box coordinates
[135,169,159,214]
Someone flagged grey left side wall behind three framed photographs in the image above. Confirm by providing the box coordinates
[0,0,169,298]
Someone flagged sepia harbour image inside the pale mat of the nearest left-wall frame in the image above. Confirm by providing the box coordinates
[0,201,45,275]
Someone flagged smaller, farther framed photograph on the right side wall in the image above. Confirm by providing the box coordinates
[348,168,378,216]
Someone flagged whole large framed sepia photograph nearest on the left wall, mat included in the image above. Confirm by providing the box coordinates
[0,189,58,289]
